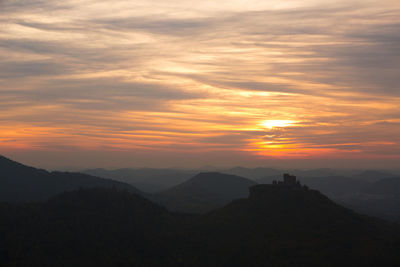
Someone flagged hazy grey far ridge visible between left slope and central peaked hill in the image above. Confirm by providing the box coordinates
[82,168,195,193]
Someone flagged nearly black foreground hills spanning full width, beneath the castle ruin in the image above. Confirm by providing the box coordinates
[0,185,400,267]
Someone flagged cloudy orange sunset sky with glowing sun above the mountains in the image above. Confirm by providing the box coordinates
[0,0,400,168]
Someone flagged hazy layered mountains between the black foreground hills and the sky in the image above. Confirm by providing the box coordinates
[0,156,400,222]
